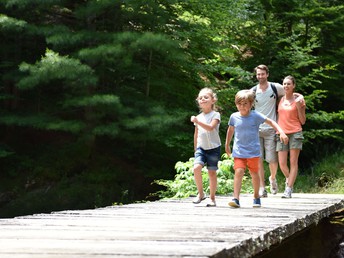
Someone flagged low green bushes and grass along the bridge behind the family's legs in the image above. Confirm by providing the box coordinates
[155,150,344,199]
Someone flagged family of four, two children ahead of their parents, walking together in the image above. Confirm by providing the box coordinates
[191,65,306,208]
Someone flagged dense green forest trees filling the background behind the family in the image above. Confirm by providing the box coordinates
[0,0,344,217]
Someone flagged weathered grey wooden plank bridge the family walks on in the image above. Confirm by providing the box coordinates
[0,194,344,258]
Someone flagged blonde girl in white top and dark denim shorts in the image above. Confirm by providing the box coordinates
[190,88,221,207]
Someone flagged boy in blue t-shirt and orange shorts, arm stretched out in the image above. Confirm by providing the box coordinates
[225,90,288,208]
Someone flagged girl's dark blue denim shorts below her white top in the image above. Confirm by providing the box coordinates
[194,146,221,170]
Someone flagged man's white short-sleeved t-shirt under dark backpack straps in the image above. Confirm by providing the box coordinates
[254,82,284,128]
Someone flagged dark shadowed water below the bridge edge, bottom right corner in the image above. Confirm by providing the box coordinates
[255,209,344,258]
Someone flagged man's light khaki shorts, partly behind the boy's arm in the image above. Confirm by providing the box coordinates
[259,128,278,163]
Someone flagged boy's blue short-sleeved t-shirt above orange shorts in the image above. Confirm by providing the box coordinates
[228,110,267,158]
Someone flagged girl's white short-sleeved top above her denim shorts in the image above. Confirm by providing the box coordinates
[197,110,221,150]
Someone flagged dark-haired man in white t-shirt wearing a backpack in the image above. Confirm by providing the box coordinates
[251,65,284,197]
